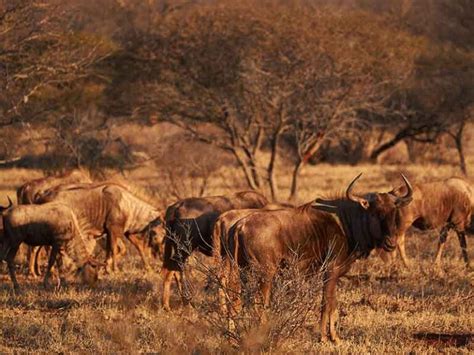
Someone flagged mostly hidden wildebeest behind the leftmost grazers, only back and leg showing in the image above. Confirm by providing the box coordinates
[16,170,92,277]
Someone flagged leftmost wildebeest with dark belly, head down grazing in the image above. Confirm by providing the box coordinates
[0,201,99,292]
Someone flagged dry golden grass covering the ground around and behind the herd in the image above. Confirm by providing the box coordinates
[0,165,474,353]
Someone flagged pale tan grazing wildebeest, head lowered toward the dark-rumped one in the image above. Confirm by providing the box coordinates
[38,183,162,270]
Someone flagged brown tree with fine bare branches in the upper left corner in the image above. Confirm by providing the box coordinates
[0,0,114,167]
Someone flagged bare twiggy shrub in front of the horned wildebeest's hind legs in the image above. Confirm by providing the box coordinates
[165,227,324,352]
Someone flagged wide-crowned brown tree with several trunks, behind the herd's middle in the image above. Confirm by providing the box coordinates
[133,3,420,198]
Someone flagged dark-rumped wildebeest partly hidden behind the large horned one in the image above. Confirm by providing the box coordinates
[162,191,268,310]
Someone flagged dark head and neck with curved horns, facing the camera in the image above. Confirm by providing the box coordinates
[313,174,413,257]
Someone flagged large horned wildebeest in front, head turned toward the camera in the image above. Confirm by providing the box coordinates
[220,175,411,342]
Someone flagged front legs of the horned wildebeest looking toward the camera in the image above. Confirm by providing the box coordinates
[321,270,340,343]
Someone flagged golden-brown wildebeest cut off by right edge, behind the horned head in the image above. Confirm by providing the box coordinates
[372,177,474,266]
